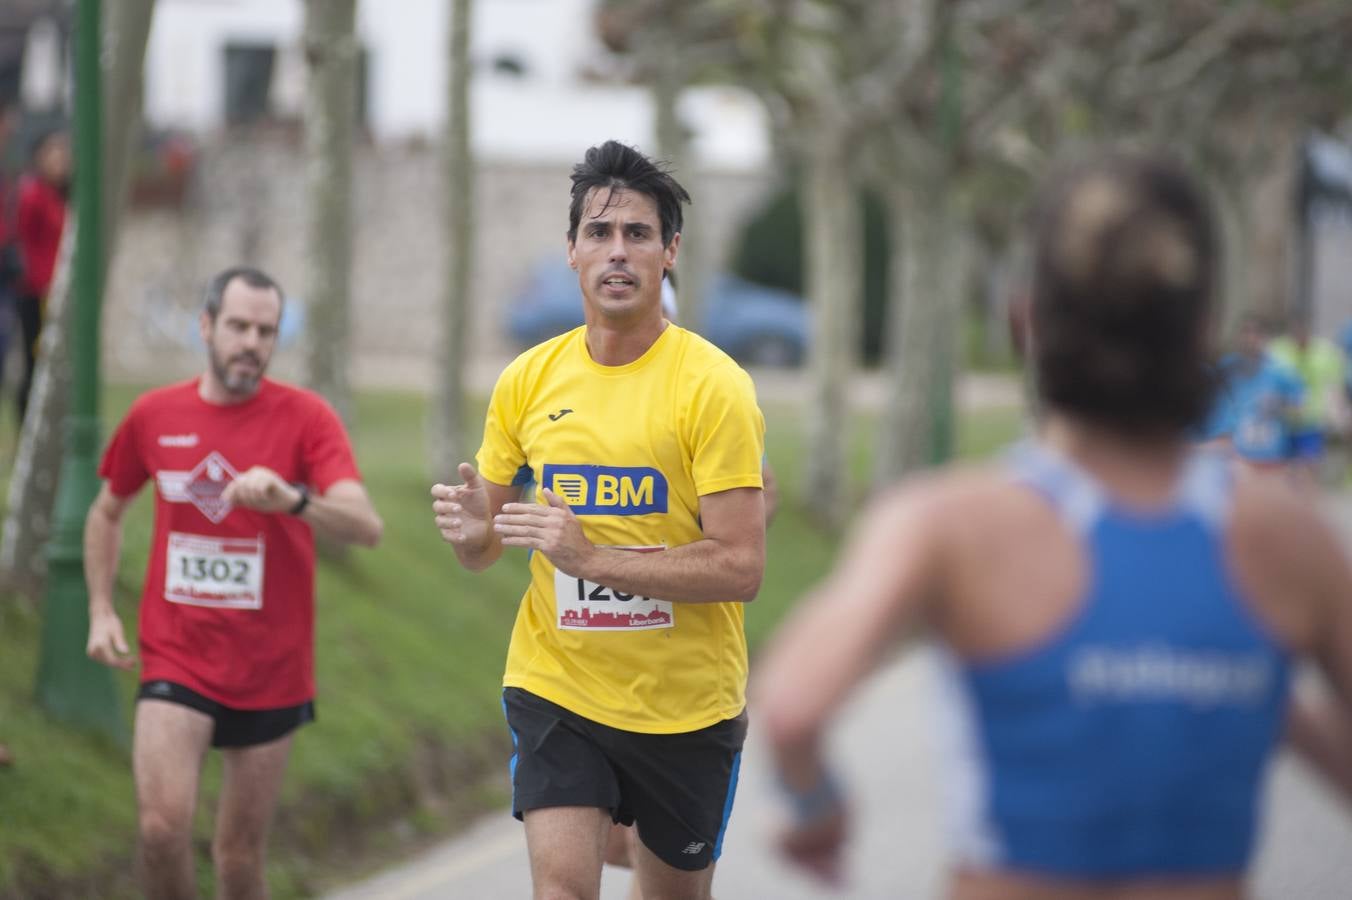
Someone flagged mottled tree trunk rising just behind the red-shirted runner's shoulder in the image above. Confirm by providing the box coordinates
[304,0,357,424]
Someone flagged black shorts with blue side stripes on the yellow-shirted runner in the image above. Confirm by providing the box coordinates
[503,688,746,872]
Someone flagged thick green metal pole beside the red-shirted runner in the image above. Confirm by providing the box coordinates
[38,0,127,742]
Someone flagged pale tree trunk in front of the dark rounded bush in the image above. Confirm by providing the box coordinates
[802,127,864,527]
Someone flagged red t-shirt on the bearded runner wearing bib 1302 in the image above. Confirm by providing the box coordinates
[99,378,361,709]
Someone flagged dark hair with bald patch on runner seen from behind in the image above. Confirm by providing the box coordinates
[1033,155,1217,436]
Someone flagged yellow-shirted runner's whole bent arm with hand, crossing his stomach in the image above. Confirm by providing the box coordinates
[493,488,765,603]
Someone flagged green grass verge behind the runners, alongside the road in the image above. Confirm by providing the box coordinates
[0,388,1018,897]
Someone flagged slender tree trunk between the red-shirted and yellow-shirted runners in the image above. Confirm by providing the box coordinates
[431,0,475,482]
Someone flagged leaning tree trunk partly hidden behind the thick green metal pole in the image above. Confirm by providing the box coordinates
[0,0,155,599]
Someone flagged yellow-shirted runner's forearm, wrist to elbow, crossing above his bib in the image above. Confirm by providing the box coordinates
[577,538,765,603]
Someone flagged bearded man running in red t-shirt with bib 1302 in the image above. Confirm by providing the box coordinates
[85,268,381,899]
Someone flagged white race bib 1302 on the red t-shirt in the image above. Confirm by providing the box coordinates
[165,531,264,609]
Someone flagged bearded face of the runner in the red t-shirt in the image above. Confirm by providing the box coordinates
[200,278,281,397]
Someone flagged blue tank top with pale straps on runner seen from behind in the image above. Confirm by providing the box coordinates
[940,445,1290,878]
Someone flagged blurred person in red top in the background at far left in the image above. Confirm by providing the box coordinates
[15,131,70,419]
